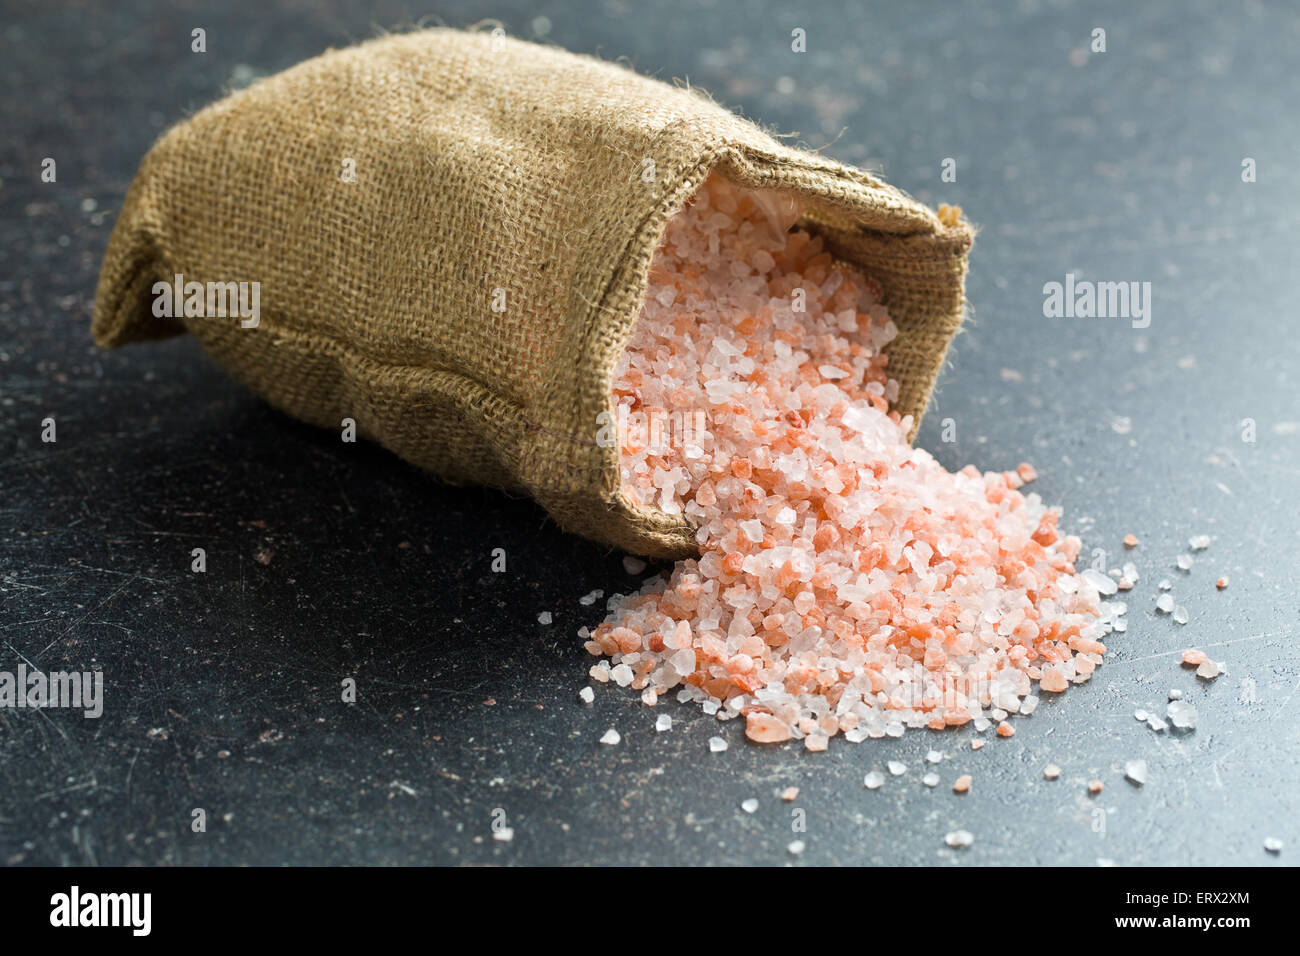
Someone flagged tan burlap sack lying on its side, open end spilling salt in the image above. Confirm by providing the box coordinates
[94,30,971,557]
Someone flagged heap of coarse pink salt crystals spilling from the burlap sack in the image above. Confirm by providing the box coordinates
[586,177,1110,749]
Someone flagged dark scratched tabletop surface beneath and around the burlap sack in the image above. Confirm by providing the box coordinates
[0,0,1300,865]
